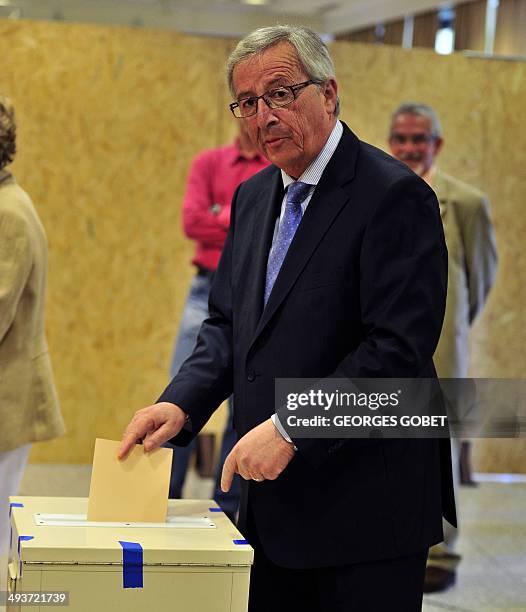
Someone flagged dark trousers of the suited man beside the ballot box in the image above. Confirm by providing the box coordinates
[248,510,427,612]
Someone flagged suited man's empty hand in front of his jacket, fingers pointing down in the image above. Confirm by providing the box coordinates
[221,419,294,492]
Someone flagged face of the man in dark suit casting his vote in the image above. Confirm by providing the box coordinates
[233,42,337,178]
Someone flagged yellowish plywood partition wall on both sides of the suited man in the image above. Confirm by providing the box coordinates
[0,21,526,472]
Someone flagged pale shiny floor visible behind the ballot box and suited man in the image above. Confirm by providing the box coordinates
[0,465,526,612]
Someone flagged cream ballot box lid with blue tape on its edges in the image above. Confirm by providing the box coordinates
[10,496,254,566]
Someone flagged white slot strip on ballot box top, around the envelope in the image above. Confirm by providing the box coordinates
[33,512,216,529]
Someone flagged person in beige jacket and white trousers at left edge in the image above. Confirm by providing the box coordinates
[0,94,64,558]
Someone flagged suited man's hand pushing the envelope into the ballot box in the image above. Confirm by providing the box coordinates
[117,402,186,459]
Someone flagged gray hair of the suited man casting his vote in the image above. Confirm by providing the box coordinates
[226,25,340,116]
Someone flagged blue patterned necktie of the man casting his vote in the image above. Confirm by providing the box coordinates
[264,181,312,305]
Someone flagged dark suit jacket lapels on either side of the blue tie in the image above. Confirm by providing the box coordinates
[251,124,359,352]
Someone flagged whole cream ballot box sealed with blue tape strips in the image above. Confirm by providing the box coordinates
[7,497,254,612]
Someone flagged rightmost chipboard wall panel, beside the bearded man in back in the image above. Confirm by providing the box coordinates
[471,61,526,473]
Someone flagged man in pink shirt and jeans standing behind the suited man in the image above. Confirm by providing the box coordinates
[170,122,269,517]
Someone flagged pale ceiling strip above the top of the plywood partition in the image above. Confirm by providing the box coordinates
[0,0,468,36]
